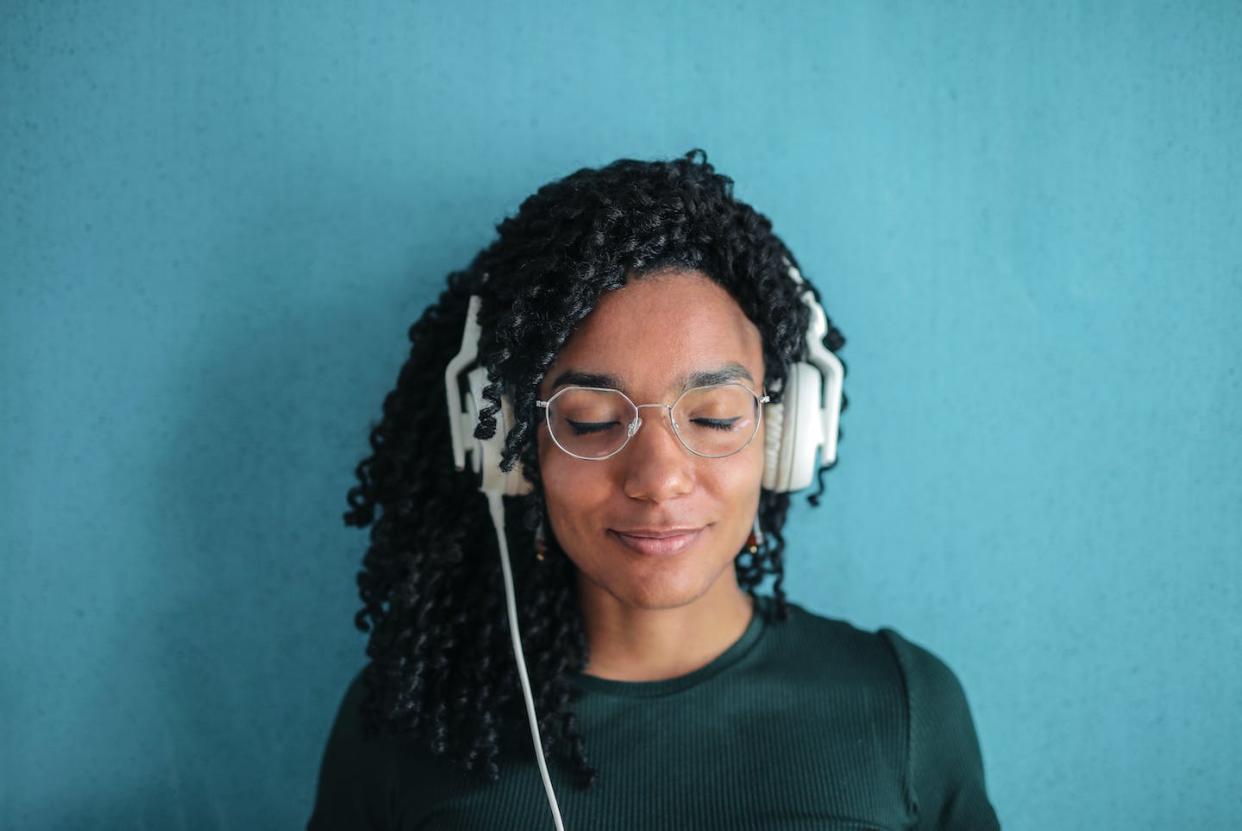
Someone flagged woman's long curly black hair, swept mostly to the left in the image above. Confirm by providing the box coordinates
[345,150,846,788]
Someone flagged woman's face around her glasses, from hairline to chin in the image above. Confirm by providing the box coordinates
[538,271,764,609]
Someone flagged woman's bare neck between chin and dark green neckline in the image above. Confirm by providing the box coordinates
[578,566,754,681]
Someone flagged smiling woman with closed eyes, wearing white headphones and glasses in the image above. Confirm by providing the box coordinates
[309,152,999,831]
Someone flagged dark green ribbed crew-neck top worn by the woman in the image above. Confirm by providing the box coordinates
[309,596,1000,831]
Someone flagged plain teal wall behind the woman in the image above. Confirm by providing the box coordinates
[0,0,1242,831]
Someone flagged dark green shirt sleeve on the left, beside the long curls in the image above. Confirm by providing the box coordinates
[307,673,394,831]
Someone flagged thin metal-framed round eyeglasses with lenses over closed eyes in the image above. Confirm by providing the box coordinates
[535,383,768,461]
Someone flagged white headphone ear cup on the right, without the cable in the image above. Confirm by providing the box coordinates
[764,363,823,493]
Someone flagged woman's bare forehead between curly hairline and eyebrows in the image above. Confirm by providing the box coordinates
[543,271,764,396]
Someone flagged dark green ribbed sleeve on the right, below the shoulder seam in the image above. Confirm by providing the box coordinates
[881,629,1000,831]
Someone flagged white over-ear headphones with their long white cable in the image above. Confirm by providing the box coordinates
[445,260,845,831]
